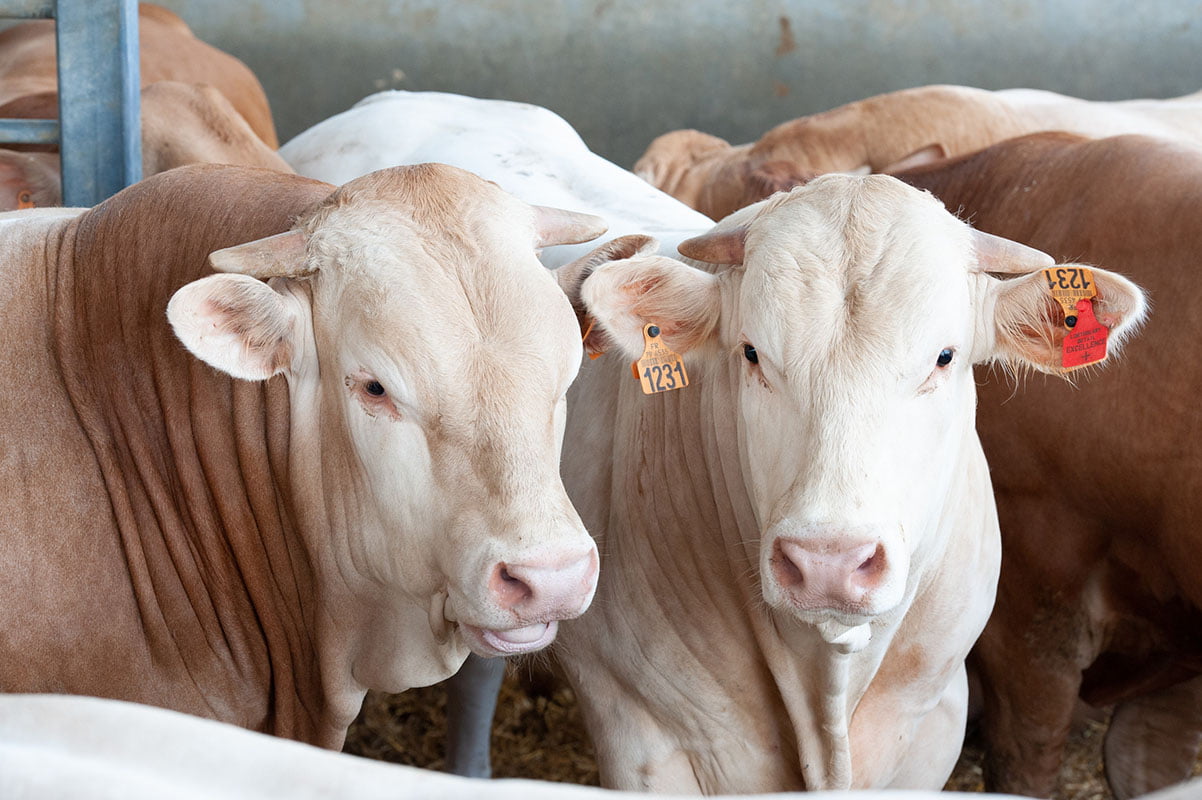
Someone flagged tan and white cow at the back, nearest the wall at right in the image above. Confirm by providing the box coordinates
[635,85,1202,220]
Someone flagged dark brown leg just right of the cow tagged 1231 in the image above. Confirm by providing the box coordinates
[974,622,1082,798]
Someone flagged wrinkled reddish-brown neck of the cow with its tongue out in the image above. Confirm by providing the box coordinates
[48,167,329,741]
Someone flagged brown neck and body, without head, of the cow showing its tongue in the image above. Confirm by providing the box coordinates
[0,166,337,744]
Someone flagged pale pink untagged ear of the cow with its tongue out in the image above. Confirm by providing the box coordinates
[167,275,303,381]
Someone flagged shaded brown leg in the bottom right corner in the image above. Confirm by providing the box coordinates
[1103,677,1202,800]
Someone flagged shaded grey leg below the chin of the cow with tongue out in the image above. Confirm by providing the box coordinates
[446,655,505,778]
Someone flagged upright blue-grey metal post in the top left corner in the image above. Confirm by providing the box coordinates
[55,0,142,205]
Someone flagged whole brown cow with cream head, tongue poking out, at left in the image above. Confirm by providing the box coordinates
[0,165,605,747]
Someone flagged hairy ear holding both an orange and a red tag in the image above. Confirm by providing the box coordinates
[990,267,1148,375]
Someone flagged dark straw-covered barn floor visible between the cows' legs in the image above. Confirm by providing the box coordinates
[345,667,1153,800]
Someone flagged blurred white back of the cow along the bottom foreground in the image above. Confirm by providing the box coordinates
[0,694,1062,800]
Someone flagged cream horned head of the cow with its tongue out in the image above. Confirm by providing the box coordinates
[168,165,605,655]
